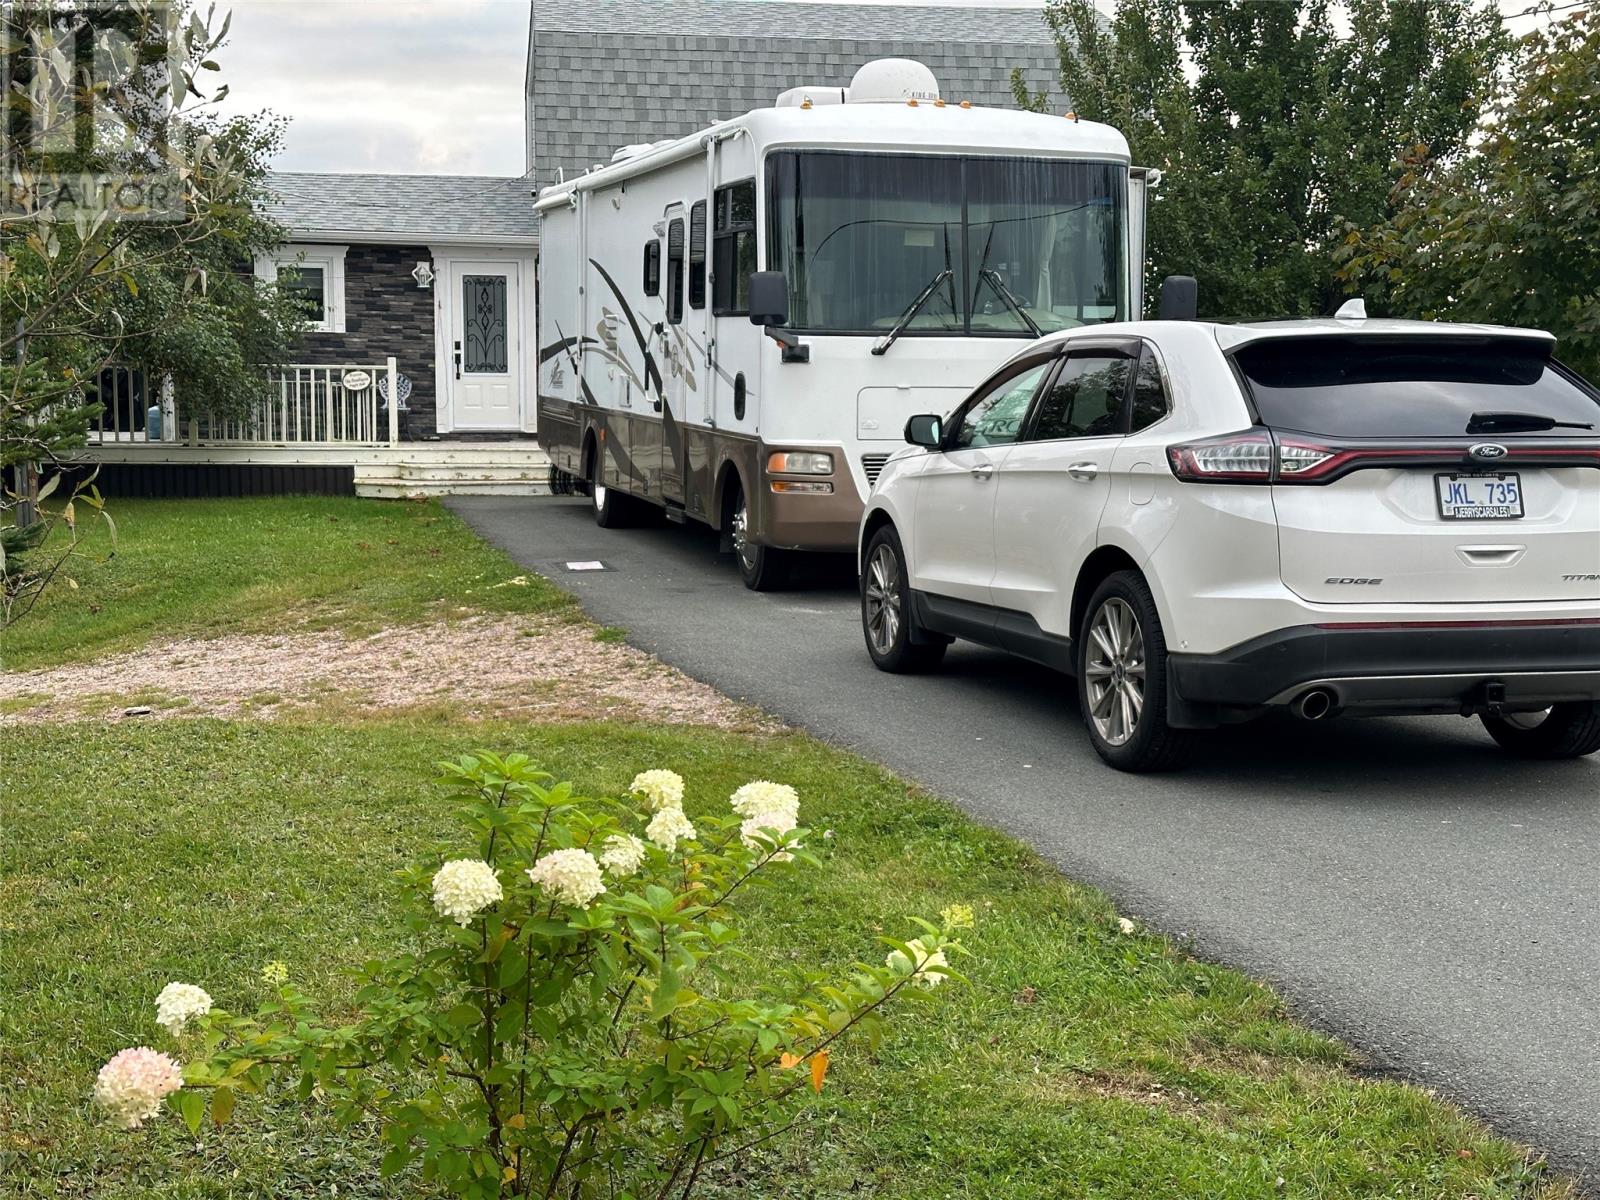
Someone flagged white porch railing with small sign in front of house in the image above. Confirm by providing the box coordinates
[90,358,400,446]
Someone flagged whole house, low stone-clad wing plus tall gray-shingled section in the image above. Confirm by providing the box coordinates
[85,0,1058,496]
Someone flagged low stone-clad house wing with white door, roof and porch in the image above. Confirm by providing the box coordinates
[91,171,549,496]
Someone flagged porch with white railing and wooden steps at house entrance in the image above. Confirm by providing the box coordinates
[80,358,550,498]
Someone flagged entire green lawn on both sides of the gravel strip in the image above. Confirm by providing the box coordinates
[0,499,1571,1200]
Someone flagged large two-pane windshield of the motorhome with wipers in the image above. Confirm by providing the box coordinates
[768,150,1128,338]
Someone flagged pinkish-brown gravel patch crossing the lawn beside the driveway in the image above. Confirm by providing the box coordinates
[0,616,778,731]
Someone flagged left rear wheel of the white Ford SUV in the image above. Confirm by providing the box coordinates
[1077,571,1200,773]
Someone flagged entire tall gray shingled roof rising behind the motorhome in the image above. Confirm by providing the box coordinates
[526,0,1061,186]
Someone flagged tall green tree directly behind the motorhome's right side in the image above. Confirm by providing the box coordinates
[1013,0,1507,317]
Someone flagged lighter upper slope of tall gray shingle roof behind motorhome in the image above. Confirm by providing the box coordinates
[533,0,1051,45]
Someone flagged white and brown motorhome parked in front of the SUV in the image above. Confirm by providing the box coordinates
[536,59,1146,589]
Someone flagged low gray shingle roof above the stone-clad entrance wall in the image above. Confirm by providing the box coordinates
[267,171,538,245]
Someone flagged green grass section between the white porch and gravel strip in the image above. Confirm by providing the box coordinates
[3,496,571,670]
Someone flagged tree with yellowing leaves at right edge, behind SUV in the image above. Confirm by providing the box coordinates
[1339,8,1600,379]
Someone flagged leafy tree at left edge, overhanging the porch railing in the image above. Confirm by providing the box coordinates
[0,0,298,626]
